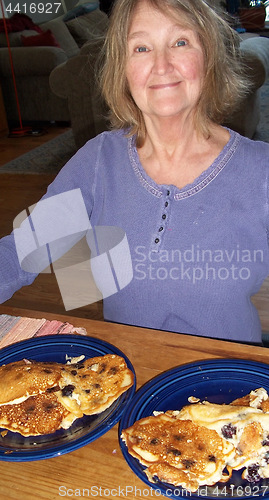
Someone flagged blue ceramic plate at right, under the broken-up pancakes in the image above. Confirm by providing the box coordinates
[119,359,269,500]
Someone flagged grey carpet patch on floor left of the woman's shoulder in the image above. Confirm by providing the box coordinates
[0,130,77,175]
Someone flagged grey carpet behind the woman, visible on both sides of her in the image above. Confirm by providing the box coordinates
[0,79,269,175]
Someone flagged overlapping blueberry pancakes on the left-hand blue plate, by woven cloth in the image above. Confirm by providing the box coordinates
[0,354,134,436]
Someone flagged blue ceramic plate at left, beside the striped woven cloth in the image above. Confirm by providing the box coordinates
[0,335,135,462]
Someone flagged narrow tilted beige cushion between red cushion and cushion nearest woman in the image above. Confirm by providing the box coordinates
[40,16,79,58]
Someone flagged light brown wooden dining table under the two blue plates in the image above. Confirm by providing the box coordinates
[0,305,269,500]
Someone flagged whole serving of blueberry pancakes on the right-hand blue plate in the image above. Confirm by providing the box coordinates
[121,388,269,492]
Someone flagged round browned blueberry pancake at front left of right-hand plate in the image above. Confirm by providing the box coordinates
[121,414,234,491]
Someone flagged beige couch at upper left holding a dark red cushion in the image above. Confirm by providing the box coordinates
[0,9,108,123]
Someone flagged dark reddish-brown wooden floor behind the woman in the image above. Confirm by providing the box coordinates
[0,123,269,332]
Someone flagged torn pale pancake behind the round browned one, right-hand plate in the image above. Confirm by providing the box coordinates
[172,388,269,482]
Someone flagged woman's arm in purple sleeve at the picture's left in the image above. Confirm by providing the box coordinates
[0,133,100,303]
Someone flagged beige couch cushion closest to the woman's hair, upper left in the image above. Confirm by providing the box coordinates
[66,9,108,47]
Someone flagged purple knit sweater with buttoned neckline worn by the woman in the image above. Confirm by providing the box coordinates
[0,131,269,342]
